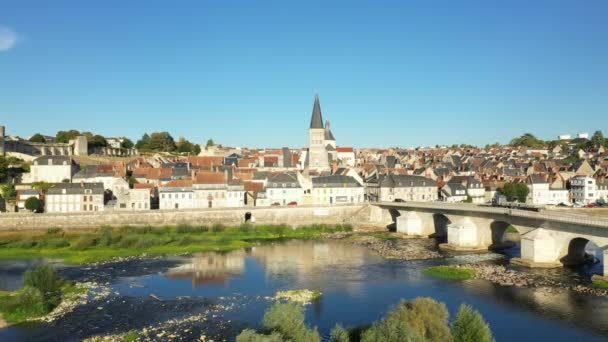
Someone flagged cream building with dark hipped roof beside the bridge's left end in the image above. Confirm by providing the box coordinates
[378,174,438,202]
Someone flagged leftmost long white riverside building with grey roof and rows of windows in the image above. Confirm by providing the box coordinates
[45,183,104,213]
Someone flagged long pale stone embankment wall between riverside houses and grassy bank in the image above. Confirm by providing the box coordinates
[0,204,377,230]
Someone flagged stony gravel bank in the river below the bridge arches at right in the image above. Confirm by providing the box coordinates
[454,262,608,296]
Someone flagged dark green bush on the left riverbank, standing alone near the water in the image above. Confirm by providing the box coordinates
[23,265,64,311]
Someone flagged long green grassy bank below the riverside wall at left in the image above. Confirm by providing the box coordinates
[0,224,352,264]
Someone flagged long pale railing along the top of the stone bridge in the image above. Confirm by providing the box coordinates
[372,202,608,228]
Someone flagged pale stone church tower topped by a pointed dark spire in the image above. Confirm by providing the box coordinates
[306,95,329,169]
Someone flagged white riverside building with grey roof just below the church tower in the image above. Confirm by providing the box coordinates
[312,175,365,205]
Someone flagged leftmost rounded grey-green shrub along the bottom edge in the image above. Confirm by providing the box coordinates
[262,302,321,342]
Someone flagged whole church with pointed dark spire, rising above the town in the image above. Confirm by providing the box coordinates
[304,95,338,171]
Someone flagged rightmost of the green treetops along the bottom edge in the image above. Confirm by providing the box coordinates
[452,304,494,342]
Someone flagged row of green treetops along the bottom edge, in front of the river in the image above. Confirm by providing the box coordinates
[236,298,494,342]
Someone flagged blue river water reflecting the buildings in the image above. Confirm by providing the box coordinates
[0,241,608,341]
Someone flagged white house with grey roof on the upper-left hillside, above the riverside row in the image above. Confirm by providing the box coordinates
[26,156,78,183]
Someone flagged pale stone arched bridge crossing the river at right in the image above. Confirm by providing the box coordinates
[372,202,608,277]
